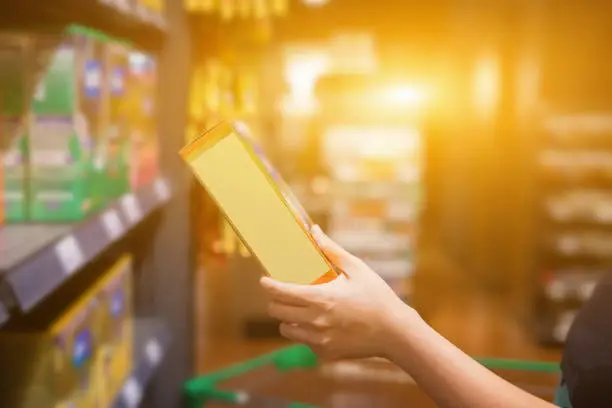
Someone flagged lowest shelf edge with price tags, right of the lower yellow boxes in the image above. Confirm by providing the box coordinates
[110,321,172,408]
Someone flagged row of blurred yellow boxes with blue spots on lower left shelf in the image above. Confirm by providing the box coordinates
[0,255,134,408]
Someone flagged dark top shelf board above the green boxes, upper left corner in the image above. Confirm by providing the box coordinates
[0,0,166,49]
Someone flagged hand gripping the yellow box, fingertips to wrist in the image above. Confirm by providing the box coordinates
[261,227,416,359]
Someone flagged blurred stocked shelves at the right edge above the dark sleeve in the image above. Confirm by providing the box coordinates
[534,111,612,343]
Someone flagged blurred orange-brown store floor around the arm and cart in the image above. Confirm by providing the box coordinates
[196,242,560,408]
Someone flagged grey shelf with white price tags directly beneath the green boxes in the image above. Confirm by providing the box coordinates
[0,178,170,311]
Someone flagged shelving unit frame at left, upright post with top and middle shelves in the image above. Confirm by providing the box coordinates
[0,0,195,408]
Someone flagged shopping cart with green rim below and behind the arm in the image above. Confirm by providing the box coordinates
[185,345,570,408]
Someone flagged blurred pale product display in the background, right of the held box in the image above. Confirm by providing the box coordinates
[322,119,422,300]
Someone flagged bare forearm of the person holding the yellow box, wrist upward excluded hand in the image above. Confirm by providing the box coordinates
[387,307,553,408]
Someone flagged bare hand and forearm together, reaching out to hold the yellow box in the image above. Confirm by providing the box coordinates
[261,227,554,408]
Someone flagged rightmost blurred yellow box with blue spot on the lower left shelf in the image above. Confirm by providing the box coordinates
[95,255,134,407]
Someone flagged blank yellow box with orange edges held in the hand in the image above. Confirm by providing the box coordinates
[180,123,338,284]
